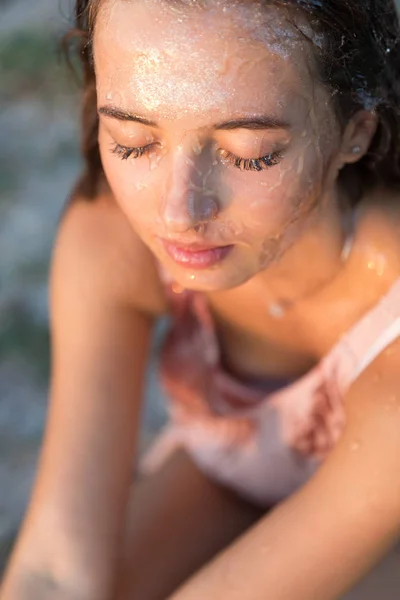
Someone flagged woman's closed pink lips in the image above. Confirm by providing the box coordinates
[161,239,233,269]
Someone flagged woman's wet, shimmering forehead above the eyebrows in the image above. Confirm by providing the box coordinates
[94,0,313,119]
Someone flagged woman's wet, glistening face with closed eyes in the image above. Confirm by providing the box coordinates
[94,0,340,290]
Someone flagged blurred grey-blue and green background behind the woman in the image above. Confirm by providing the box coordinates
[0,0,400,573]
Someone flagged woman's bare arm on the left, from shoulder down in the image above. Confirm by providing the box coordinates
[0,198,163,600]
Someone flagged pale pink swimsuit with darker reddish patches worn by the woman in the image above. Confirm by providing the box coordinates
[142,280,400,507]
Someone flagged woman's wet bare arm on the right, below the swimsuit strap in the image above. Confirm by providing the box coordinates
[172,342,400,600]
